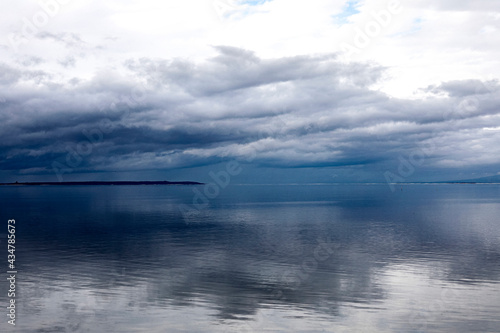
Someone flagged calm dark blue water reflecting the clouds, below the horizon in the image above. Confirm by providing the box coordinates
[0,185,500,332]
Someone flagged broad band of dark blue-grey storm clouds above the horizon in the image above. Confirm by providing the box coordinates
[0,45,500,178]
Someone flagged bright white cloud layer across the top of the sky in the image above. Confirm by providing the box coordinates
[0,0,500,97]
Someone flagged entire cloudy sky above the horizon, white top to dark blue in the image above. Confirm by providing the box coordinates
[0,0,500,184]
